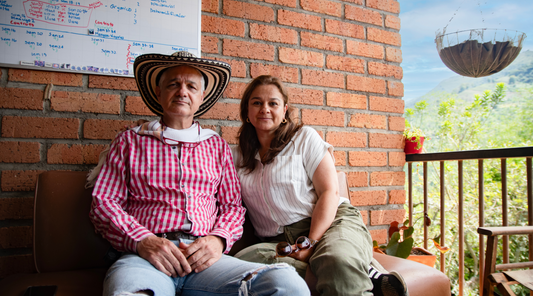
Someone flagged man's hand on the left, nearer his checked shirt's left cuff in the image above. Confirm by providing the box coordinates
[137,235,192,277]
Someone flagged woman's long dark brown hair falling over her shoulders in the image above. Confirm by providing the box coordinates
[237,75,302,173]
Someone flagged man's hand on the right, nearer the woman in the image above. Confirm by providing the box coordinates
[180,235,224,272]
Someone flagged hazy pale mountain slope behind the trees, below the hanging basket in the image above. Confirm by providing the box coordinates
[405,50,533,108]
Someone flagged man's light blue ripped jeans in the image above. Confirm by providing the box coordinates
[104,240,310,296]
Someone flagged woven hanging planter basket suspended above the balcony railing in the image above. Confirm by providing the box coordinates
[435,29,526,77]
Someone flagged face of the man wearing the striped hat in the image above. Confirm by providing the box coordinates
[155,66,204,118]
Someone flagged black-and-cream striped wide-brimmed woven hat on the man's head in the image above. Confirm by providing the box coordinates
[133,51,231,117]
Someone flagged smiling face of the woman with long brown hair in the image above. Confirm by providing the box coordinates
[248,84,288,134]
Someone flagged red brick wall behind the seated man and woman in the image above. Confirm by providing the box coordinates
[0,0,405,278]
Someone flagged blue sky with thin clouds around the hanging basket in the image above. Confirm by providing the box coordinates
[399,0,533,100]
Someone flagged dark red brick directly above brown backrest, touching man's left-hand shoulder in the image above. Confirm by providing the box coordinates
[46,144,107,164]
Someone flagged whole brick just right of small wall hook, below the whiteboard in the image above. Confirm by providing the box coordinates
[50,91,120,114]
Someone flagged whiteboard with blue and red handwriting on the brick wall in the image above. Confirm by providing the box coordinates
[0,0,201,77]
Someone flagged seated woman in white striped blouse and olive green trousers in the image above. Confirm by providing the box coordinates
[233,75,404,295]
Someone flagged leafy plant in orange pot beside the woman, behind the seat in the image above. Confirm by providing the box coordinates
[373,220,437,267]
